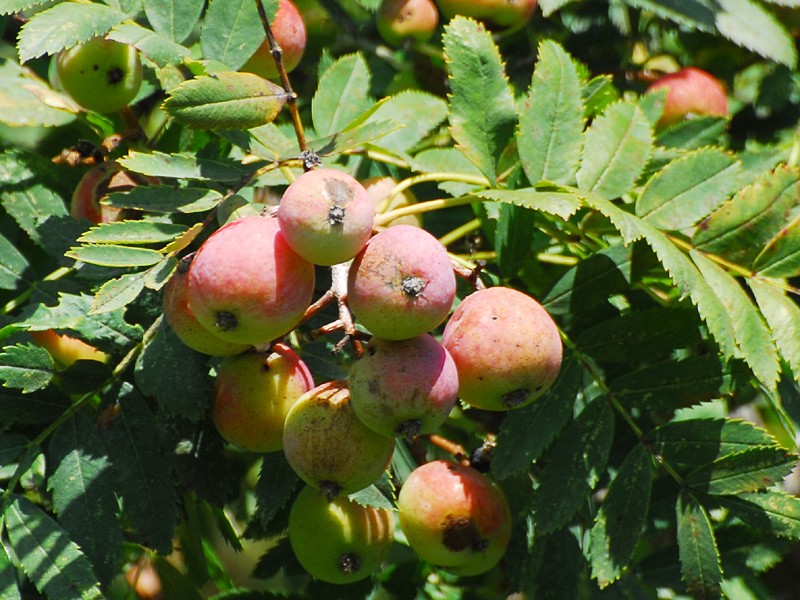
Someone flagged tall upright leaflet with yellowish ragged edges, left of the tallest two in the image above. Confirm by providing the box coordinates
[442,17,517,184]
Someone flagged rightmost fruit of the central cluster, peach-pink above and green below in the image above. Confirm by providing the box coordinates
[442,286,562,410]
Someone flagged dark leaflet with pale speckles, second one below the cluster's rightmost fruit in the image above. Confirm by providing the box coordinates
[532,398,614,533]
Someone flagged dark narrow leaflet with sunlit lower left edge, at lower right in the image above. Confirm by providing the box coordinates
[590,444,654,589]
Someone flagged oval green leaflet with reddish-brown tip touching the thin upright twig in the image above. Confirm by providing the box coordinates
[164,71,288,129]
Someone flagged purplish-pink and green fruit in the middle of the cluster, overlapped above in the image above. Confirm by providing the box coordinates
[347,333,458,439]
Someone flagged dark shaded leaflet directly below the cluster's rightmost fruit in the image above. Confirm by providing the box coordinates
[492,357,583,478]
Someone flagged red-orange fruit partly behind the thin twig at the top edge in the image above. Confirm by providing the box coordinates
[240,0,306,79]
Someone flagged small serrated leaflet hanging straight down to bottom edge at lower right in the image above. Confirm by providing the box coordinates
[676,493,722,600]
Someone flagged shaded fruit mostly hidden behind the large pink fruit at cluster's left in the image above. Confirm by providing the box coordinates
[162,255,250,356]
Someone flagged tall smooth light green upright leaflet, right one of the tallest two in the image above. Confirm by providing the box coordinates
[517,41,584,184]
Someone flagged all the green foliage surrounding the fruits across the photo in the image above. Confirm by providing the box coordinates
[0,0,800,599]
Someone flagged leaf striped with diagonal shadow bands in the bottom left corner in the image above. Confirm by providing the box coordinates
[5,496,103,600]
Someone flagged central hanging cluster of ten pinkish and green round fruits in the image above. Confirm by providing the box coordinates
[156,167,561,583]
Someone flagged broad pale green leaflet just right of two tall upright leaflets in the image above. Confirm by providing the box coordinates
[577,101,653,199]
